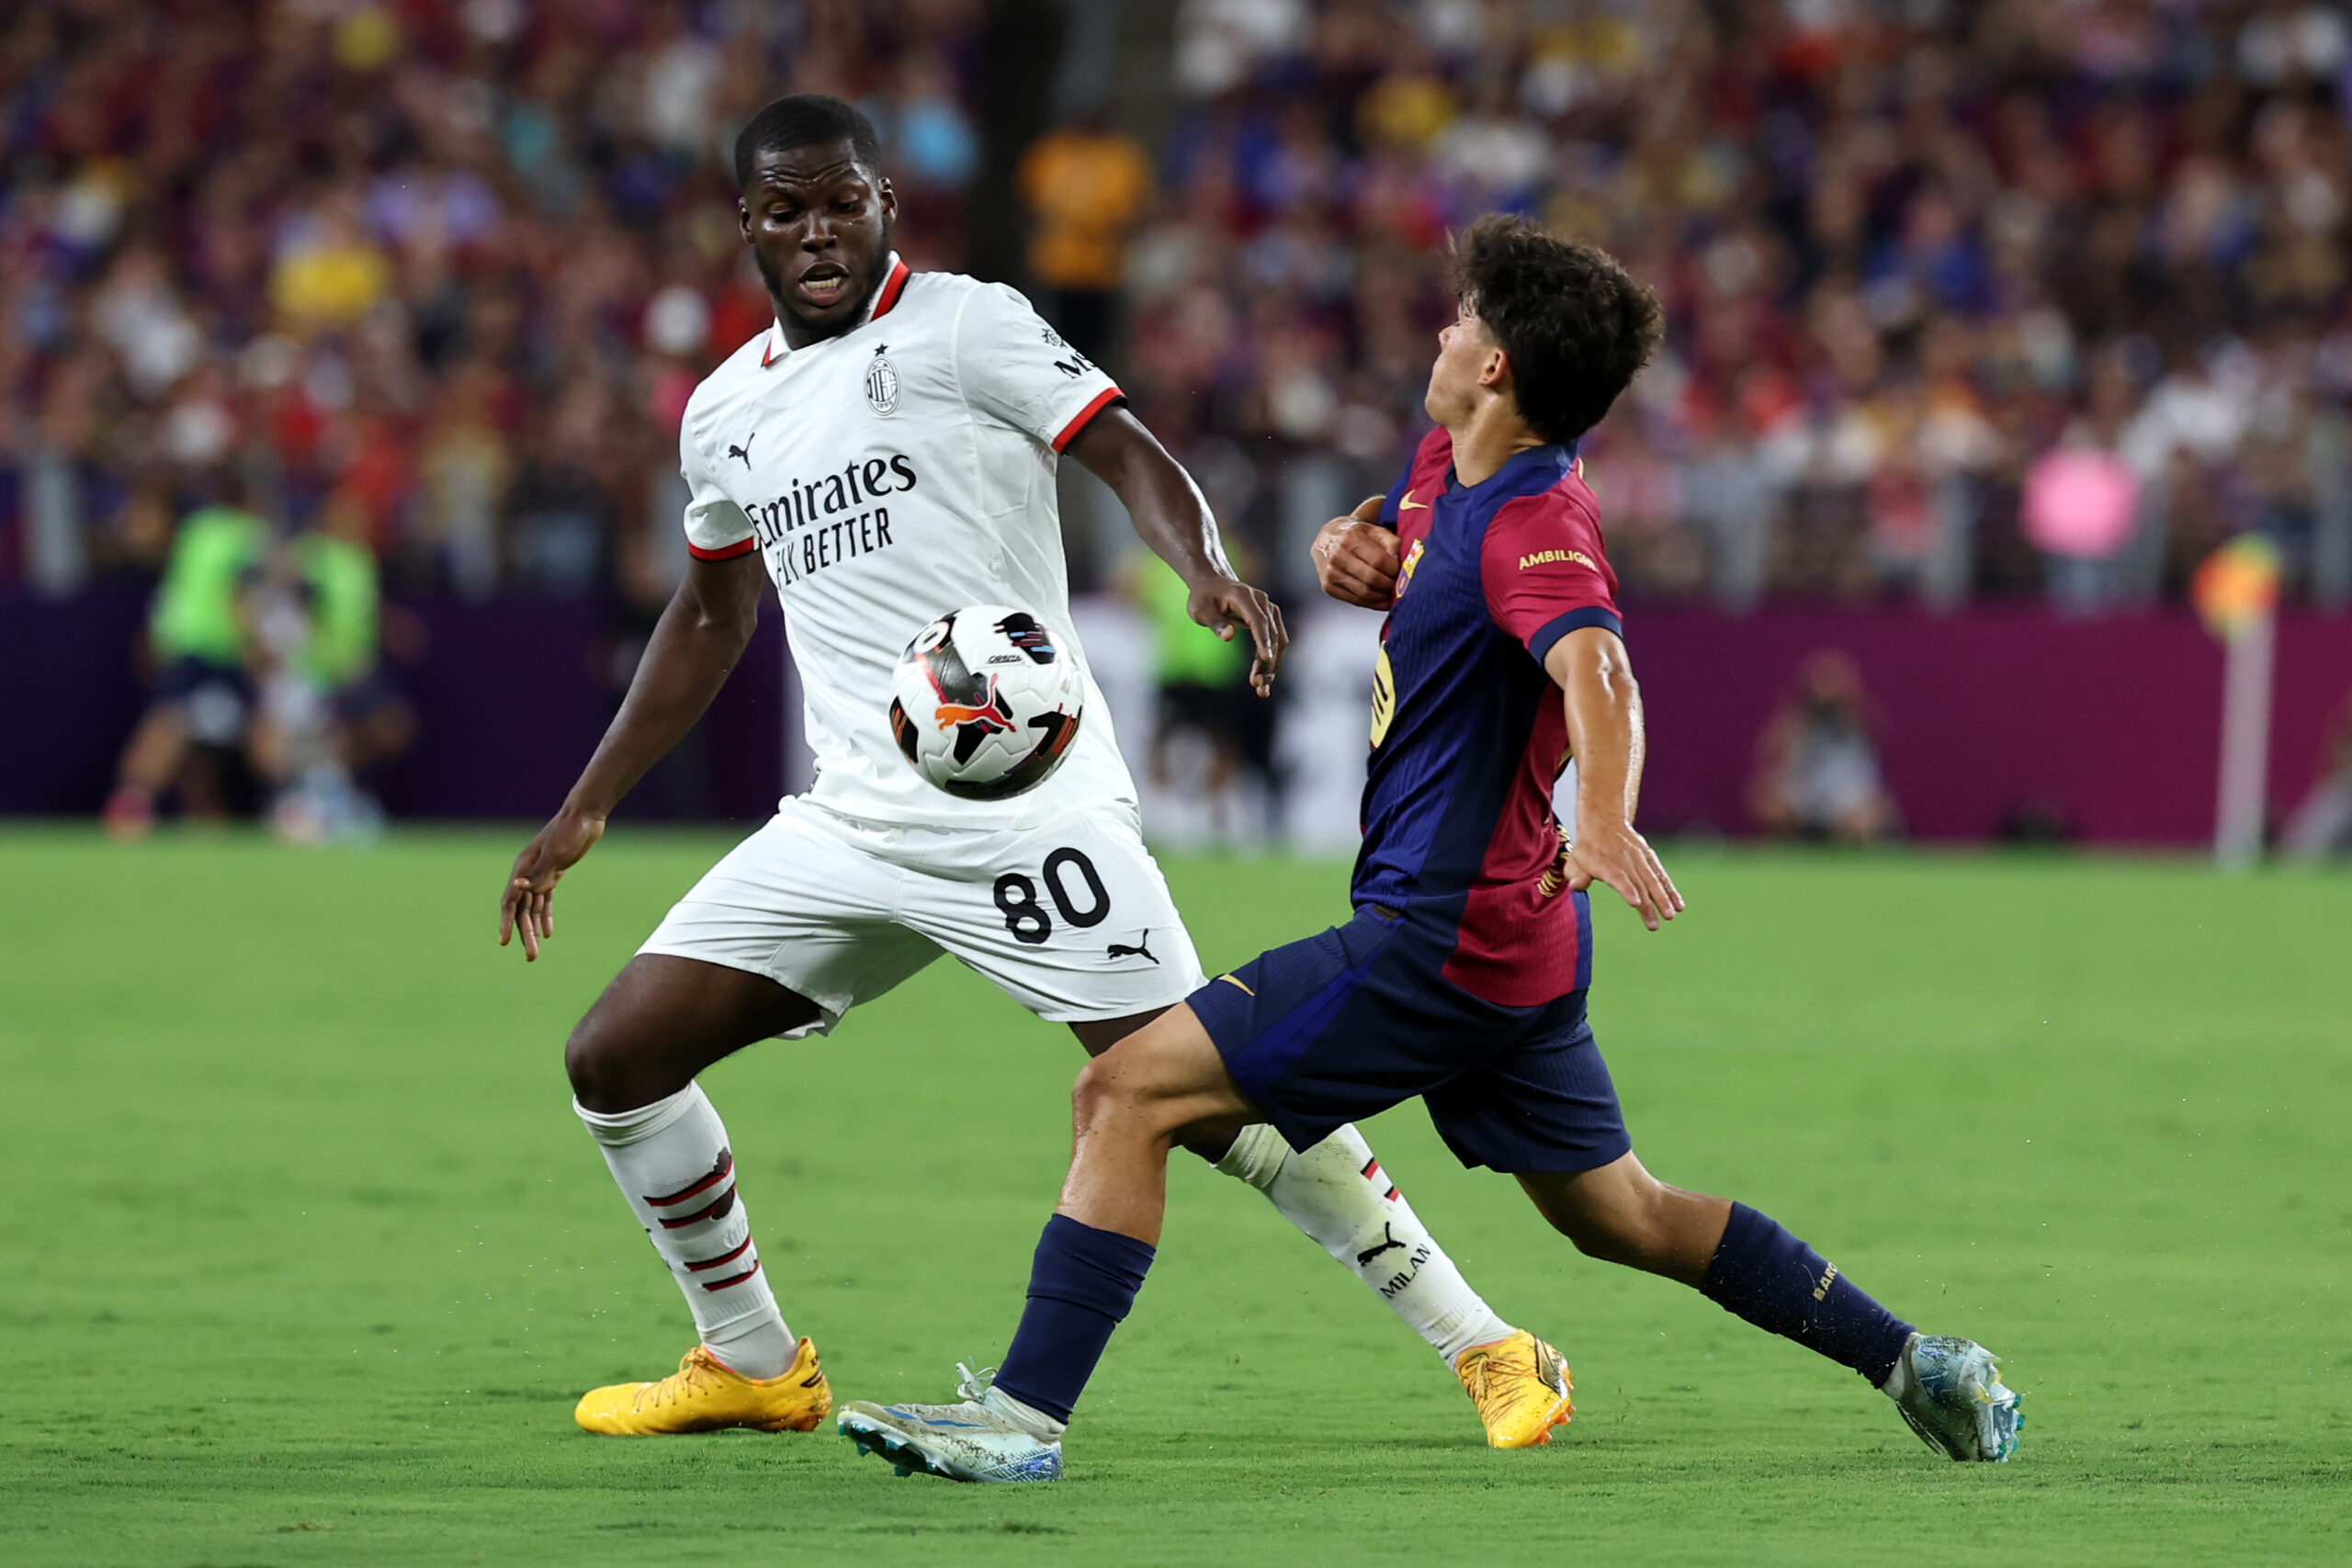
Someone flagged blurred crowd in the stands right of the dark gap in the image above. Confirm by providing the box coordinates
[1125,0,2352,609]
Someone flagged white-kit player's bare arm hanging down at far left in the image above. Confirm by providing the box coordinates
[499,558,767,959]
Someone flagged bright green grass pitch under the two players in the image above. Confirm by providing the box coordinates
[0,829,2352,1568]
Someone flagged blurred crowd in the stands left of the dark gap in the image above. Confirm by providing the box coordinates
[0,0,978,604]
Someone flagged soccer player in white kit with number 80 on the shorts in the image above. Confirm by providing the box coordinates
[499,94,1569,1446]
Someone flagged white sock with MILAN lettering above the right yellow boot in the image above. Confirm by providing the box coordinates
[1216,1123,1512,1366]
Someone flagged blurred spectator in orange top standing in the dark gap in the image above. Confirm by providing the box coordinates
[1021,108,1152,360]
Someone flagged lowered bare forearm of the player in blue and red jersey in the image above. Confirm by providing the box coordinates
[1543,626,1684,931]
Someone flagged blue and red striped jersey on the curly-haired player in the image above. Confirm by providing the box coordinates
[1352,430,1625,1006]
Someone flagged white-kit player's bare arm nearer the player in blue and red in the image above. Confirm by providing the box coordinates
[1068,409,1291,696]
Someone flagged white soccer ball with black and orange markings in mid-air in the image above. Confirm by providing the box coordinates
[889,604,1087,799]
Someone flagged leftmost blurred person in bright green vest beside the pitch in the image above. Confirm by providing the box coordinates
[106,491,270,840]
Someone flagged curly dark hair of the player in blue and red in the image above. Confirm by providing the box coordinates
[1453,211,1665,442]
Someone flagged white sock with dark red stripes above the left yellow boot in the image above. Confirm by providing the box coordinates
[571,1084,795,1378]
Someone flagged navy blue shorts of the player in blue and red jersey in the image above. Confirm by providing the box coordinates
[1188,905,1633,1170]
